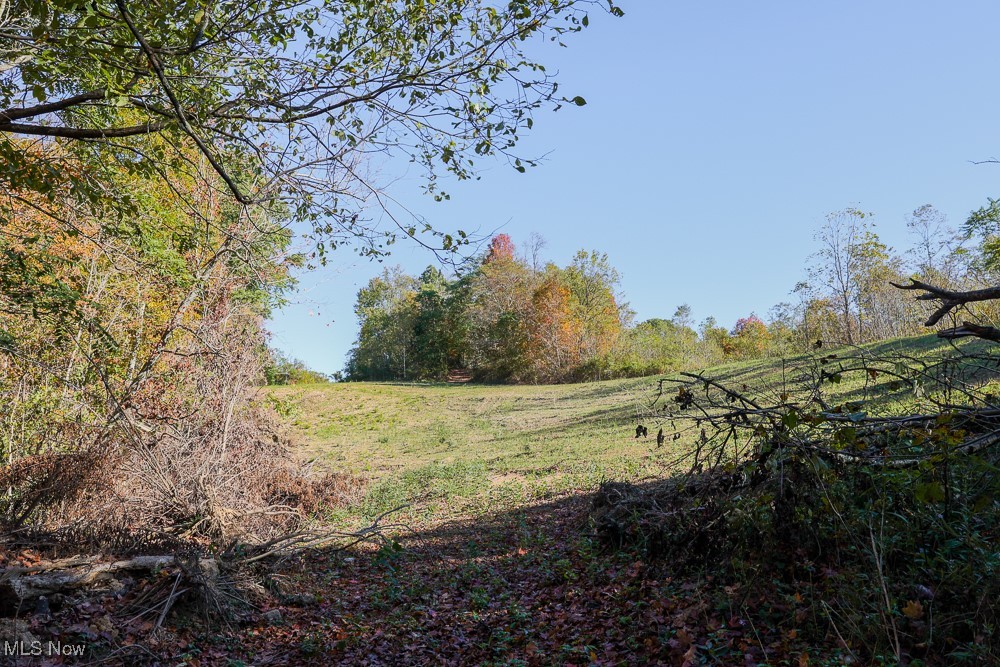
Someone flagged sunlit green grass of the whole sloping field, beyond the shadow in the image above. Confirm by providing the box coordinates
[270,336,992,521]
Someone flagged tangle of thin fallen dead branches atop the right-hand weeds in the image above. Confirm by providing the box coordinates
[651,348,1000,484]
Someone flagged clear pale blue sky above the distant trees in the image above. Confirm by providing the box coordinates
[269,0,1000,372]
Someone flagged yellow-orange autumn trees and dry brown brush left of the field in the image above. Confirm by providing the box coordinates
[0,154,293,539]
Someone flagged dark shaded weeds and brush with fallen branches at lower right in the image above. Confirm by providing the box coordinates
[593,342,1000,664]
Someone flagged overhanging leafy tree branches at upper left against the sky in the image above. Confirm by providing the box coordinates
[0,0,621,254]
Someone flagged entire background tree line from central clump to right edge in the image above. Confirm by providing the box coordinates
[343,200,1000,382]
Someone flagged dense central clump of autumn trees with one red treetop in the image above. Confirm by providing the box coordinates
[346,234,630,382]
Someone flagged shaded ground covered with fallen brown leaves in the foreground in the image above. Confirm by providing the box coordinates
[5,496,852,667]
